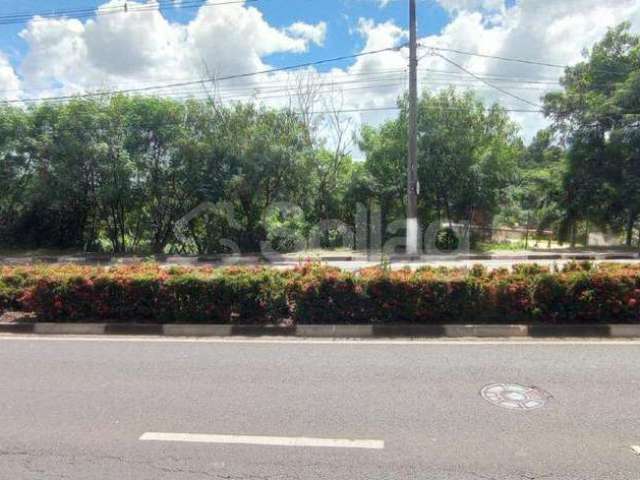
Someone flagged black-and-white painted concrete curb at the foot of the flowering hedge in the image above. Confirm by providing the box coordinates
[0,323,640,338]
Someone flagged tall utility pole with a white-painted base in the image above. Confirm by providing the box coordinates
[407,0,418,255]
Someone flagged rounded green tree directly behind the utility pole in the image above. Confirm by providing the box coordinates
[360,90,523,237]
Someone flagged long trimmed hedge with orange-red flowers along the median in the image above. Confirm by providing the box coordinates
[0,264,640,324]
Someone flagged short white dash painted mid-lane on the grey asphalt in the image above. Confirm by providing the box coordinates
[140,432,384,450]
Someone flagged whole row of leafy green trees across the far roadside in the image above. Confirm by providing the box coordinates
[0,24,640,253]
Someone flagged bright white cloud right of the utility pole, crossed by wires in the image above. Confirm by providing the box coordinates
[422,0,640,138]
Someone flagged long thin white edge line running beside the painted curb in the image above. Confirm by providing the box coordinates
[0,334,640,346]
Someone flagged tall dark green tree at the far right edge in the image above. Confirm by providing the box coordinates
[545,23,640,246]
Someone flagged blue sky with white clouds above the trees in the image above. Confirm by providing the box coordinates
[0,0,640,156]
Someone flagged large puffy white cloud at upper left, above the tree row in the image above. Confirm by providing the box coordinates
[14,0,327,96]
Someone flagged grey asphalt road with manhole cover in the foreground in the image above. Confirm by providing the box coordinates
[0,337,640,480]
